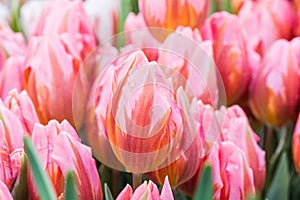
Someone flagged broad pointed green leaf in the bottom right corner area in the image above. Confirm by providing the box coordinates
[267,152,289,200]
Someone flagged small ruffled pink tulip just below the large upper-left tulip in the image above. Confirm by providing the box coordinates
[5,90,39,135]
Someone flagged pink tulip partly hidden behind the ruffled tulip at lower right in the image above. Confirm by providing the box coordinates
[220,106,266,191]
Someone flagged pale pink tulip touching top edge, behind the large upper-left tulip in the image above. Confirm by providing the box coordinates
[33,0,96,59]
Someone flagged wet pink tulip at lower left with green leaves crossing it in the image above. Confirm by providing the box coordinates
[28,120,102,199]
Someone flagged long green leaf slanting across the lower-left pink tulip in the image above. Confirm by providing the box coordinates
[24,136,56,200]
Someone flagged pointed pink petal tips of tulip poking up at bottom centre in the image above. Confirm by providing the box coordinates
[116,177,174,200]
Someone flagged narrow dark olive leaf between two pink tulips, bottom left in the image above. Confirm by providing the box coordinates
[12,154,29,200]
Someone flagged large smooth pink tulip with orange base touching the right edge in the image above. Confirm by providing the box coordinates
[249,40,299,126]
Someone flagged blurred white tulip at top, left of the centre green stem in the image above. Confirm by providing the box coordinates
[84,0,120,42]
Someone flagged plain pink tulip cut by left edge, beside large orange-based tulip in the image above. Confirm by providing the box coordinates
[0,55,24,99]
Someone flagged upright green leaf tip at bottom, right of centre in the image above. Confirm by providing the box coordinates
[194,164,213,200]
